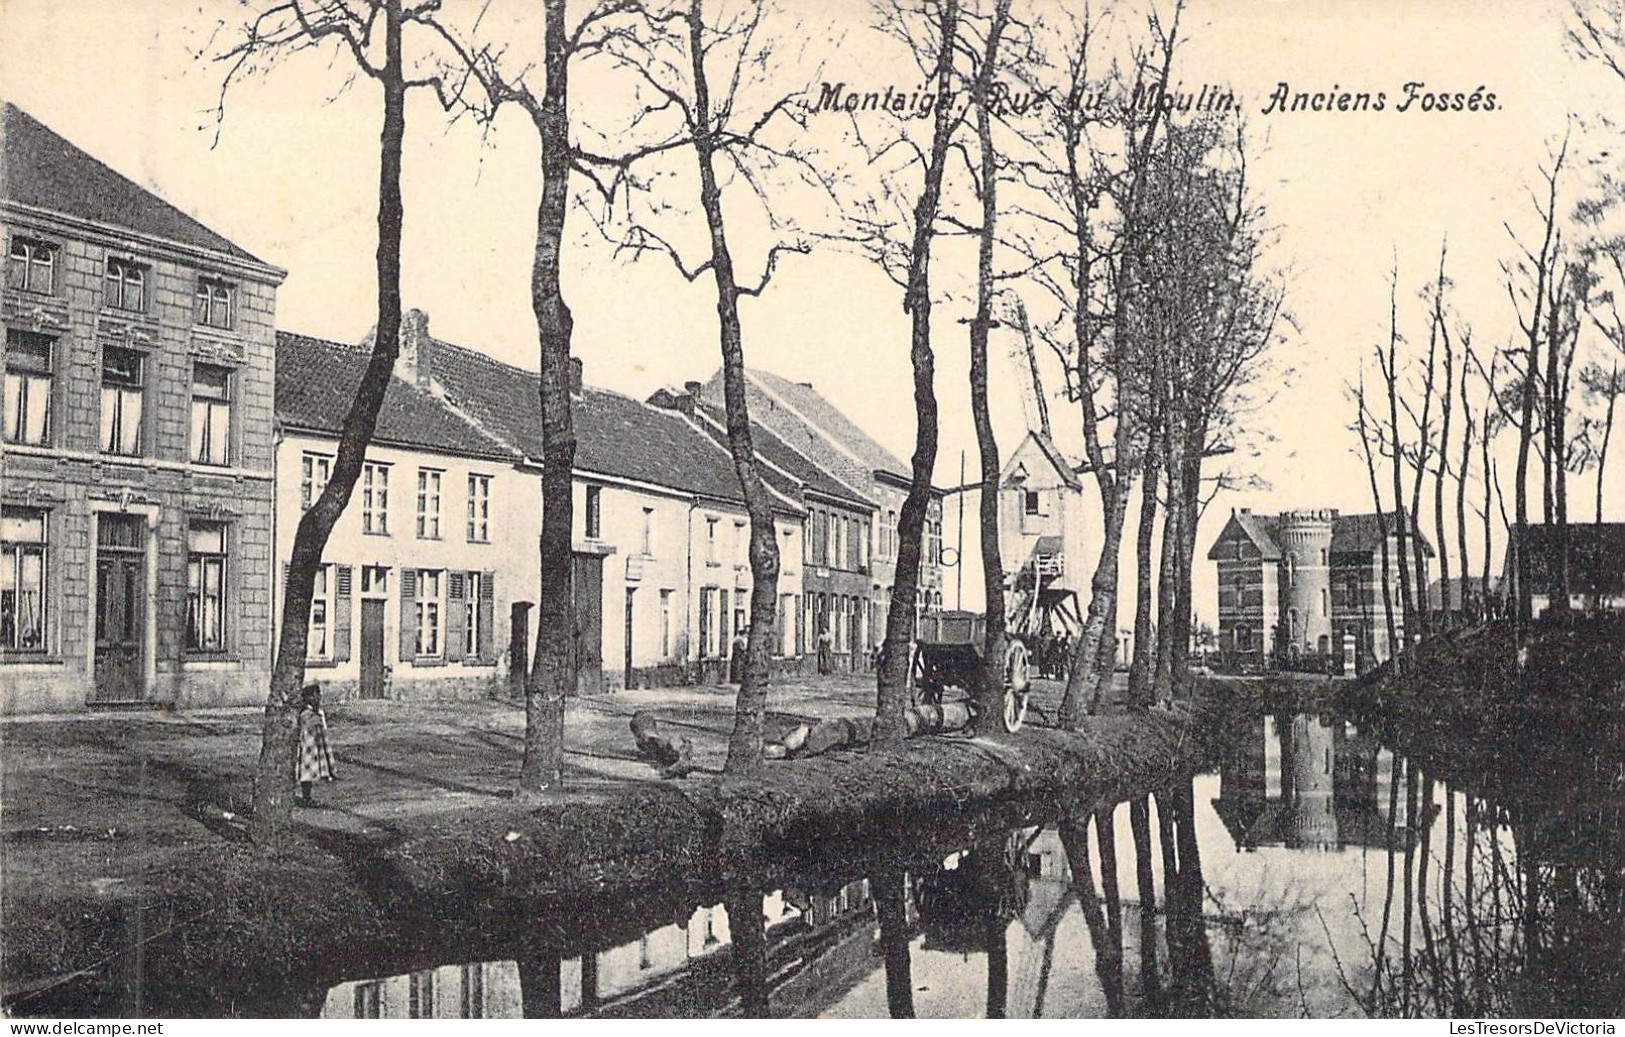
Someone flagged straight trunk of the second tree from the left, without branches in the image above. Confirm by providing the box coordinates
[518,0,577,798]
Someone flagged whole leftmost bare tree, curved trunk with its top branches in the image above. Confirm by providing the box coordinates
[213,0,458,847]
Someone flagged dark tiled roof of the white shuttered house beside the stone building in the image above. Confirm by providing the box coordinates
[276,332,518,460]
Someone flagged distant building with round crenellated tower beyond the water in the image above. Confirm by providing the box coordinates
[1207,509,1433,671]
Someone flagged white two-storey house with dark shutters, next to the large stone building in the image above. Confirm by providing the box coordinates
[276,332,523,699]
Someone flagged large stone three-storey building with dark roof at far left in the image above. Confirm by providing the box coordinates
[0,104,284,712]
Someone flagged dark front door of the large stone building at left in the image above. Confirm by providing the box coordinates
[91,515,146,704]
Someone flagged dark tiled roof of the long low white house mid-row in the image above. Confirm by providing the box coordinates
[431,340,763,502]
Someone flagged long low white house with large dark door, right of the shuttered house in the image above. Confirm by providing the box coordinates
[365,310,803,694]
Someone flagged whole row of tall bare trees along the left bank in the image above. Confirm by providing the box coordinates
[213,0,1281,842]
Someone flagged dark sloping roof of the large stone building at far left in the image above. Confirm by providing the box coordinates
[0,102,265,265]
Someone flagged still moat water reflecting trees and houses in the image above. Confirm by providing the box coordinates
[13,712,1625,1017]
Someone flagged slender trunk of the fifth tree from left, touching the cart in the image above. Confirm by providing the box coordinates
[970,0,1007,718]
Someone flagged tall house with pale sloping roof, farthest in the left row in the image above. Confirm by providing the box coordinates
[700,367,943,650]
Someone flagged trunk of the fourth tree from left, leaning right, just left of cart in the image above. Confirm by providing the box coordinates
[873,0,959,744]
